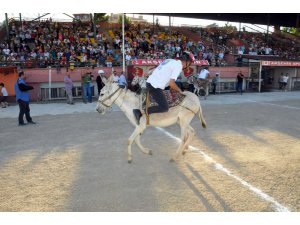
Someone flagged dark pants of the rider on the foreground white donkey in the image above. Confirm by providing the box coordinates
[146,83,169,114]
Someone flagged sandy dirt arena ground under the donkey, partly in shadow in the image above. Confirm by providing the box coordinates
[0,94,300,212]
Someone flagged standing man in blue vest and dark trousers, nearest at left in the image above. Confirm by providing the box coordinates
[15,71,36,126]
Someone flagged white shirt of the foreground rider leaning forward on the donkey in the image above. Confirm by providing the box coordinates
[147,59,182,89]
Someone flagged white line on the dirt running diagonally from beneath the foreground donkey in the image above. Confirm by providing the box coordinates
[156,127,290,212]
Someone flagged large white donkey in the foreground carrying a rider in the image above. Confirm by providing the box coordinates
[96,76,206,163]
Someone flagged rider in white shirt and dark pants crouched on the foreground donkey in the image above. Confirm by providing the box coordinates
[133,51,195,124]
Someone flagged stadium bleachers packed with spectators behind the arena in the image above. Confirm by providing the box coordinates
[0,17,300,68]
